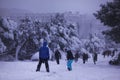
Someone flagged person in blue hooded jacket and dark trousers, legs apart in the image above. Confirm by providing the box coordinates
[36,42,49,72]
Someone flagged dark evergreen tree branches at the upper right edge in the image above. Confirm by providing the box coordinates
[95,0,120,43]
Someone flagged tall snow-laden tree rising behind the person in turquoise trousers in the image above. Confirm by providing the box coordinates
[49,13,80,50]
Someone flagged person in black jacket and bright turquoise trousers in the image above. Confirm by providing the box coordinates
[67,50,74,71]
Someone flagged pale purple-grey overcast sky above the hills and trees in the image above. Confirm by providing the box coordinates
[0,0,112,14]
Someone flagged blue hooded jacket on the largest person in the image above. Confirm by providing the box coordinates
[39,42,49,59]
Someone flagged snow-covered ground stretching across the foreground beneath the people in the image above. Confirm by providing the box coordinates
[0,56,120,80]
